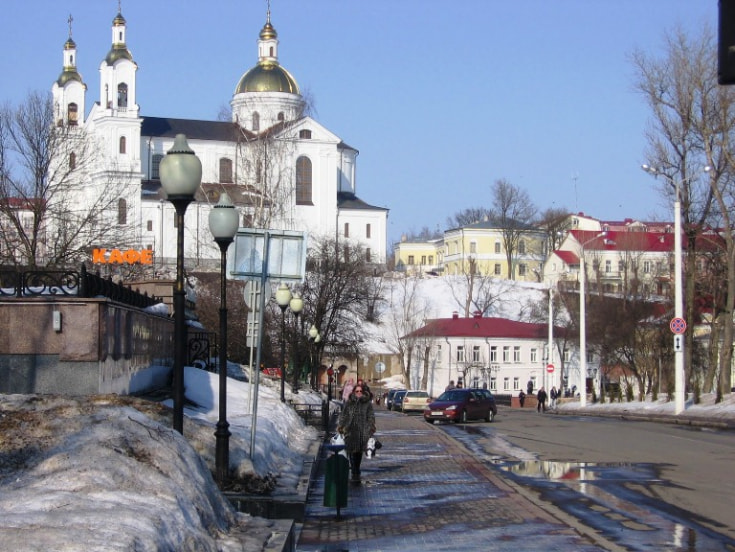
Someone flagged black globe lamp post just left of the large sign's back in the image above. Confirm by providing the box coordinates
[209,192,239,485]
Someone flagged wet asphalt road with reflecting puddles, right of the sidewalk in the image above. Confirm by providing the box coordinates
[444,410,735,551]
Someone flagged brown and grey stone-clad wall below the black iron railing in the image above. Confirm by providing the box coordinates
[0,296,174,395]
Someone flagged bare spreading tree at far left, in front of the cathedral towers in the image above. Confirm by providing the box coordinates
[0,93,139,267]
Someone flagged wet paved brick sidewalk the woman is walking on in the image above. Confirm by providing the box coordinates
[296,408,605,552]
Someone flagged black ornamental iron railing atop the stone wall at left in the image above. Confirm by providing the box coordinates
[0,265,161,308]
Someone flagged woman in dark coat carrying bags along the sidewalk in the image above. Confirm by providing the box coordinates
[337,383,375,483]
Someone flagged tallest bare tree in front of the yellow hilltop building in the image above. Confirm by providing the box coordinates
[491,179,541,280]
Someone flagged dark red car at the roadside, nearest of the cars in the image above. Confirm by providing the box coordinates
[424,389,498,424]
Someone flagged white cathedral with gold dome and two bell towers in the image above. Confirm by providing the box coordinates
[52,9,388,269]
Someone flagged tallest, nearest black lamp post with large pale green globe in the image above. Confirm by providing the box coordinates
[159,134,202,434]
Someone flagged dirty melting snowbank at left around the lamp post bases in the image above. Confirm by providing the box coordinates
[0,367,321,551]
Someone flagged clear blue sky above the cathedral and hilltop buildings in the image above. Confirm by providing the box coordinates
[0,0,717,243]
